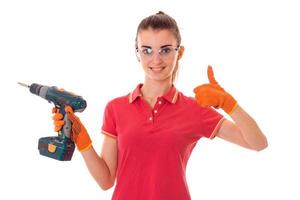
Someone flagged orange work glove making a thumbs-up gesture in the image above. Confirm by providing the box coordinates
[194,65,237,114]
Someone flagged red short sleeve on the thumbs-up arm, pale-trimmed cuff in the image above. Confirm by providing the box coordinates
[201,108,225,139]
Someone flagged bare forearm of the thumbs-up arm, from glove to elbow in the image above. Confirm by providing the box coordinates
[230,105,268,151]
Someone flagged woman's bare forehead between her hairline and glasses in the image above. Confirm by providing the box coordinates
[137,29,177,47]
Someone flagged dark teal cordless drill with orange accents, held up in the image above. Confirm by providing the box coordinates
[19,83,86,161]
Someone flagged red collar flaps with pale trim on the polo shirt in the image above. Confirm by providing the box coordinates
[129,83,178,104]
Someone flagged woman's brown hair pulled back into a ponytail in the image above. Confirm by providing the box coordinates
[135,11,181,82]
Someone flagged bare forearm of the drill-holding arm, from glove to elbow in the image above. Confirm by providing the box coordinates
[81,146,114,190]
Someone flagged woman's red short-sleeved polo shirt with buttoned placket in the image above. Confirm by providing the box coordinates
[102,84,223,200]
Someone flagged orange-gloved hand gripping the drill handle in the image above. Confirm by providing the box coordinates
[52,106,92,152]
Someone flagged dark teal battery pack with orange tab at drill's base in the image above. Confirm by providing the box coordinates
[38,136,75,161]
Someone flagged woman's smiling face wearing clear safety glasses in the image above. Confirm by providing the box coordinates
[137,28,183,82]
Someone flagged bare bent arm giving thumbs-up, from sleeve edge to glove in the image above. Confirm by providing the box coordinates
[216,106,268,151]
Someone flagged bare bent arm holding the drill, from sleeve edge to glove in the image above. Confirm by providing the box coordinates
[82,135,117,190]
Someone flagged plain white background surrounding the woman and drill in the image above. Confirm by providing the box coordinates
[0,0,300,200]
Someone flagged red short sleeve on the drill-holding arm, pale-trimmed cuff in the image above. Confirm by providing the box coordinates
[101,102,118,138]
